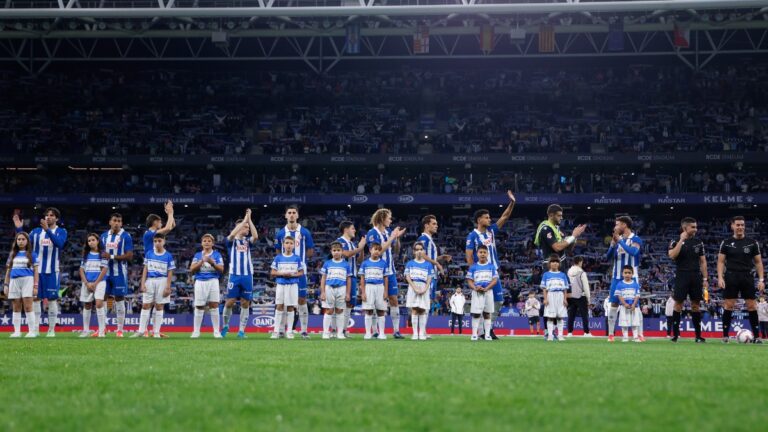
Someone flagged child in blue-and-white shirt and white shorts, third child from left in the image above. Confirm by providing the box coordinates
[134,234,176,339]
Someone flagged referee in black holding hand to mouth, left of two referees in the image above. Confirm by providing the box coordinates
[668,217,709,343]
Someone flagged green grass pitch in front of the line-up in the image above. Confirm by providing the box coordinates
[0,334,768,432]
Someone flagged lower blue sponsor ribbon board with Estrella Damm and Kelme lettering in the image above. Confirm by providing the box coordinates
[0,193,768,206]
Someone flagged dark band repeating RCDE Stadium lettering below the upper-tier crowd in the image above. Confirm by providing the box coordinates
[0,152,768,167]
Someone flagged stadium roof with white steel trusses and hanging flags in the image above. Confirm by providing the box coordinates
[0,0,768,74]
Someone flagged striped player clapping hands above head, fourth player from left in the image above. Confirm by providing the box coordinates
[221,209,259,339]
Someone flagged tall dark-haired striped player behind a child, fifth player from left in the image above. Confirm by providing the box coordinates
[275,205,315,339]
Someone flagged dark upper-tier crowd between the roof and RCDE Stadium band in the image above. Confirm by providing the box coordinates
[0,64,768,156]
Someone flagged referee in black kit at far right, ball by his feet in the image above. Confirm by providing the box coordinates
[717,216,765,343]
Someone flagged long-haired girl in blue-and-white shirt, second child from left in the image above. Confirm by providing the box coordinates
[80,233,109,337]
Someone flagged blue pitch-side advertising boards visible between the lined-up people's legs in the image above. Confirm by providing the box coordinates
[0,313,750,335]
